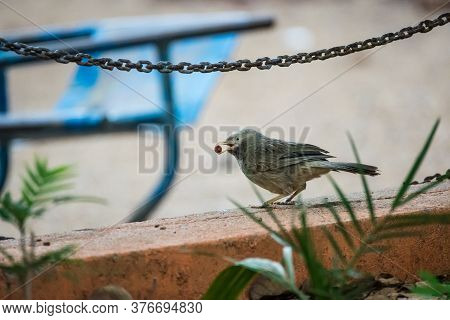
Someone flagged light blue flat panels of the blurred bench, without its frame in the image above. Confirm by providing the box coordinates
[56,18,236,125]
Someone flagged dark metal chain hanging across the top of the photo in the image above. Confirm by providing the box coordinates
[0,13,450,74]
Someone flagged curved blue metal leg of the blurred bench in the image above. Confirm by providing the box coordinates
[129,43,179,222]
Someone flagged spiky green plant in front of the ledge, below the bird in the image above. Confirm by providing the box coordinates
[203,120,450,299]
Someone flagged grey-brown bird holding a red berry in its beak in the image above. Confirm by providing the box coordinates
[214,128,379,207]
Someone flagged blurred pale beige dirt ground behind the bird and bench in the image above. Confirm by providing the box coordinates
[0,0,450,236]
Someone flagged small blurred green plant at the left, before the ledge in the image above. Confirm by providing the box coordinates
[0,157,100,299]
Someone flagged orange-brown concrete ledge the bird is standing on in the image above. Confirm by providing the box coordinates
[0,182,450,299]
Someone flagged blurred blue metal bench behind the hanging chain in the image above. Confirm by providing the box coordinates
[0,12,272,221]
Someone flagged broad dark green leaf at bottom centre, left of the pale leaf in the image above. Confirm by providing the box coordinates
[202,266,256,300]
